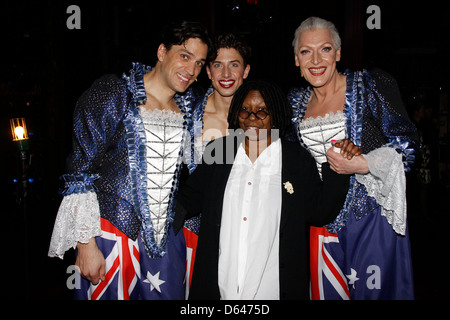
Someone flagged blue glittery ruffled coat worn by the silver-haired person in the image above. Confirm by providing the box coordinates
[288,70,420,233]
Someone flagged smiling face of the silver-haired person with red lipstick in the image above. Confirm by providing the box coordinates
[295,29,341,88]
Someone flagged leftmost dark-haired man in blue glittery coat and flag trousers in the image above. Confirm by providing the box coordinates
[49,21,211,299]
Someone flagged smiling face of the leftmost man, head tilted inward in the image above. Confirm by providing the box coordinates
[158,38,208,93]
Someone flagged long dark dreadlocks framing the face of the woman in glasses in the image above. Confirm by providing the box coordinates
[228,80,292,137]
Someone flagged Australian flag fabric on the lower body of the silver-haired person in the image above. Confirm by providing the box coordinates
[310,207,414,300]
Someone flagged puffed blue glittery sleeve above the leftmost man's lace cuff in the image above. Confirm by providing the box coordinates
[60,75,126,196]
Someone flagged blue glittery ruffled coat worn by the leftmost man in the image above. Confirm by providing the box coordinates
[61,63,198,257]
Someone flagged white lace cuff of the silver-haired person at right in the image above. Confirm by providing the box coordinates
[356,148,406,235]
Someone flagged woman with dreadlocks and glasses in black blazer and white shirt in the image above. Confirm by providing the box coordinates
[176,80,356,300]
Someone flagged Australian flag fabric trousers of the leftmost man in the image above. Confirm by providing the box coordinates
[75,218,186,300]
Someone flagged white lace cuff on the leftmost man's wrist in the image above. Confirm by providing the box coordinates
[48,192,102,259]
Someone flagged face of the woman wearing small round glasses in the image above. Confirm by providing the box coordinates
[238,90,272,145]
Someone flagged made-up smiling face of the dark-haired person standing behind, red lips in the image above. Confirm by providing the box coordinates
[206,48,250,97]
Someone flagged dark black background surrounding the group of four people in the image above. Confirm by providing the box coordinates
[0,0,450,299]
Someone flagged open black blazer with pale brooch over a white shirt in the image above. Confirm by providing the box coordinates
[174,136,349,299]
